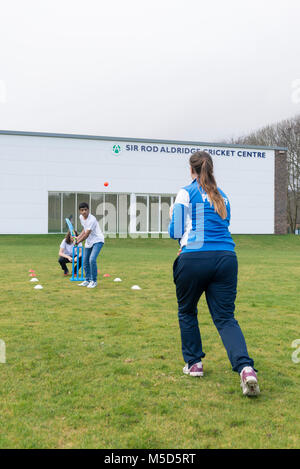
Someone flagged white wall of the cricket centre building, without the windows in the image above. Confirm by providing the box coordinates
[0,134,278,234]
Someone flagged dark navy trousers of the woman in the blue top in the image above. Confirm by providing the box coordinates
[173,251,254,373]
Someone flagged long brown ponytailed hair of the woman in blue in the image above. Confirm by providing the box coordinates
[190,151,227,220]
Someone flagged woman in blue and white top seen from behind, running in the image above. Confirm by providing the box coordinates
[169,152,259,396]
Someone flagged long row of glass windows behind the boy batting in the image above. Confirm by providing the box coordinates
[48,192,174,236]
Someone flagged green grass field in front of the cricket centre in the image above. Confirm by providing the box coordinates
[0,235,300,449]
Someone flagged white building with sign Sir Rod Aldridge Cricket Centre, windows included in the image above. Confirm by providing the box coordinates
[0,131,286,235]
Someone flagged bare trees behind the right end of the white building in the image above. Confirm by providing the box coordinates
[231,115,300,233]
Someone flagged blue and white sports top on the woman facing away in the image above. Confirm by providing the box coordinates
[169,179,235,252]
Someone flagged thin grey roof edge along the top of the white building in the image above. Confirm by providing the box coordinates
[0,130,288,151]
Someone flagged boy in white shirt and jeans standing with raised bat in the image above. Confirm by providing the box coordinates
[75,202,104,288]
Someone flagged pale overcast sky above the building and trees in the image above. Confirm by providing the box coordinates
[0,0,300,142]
